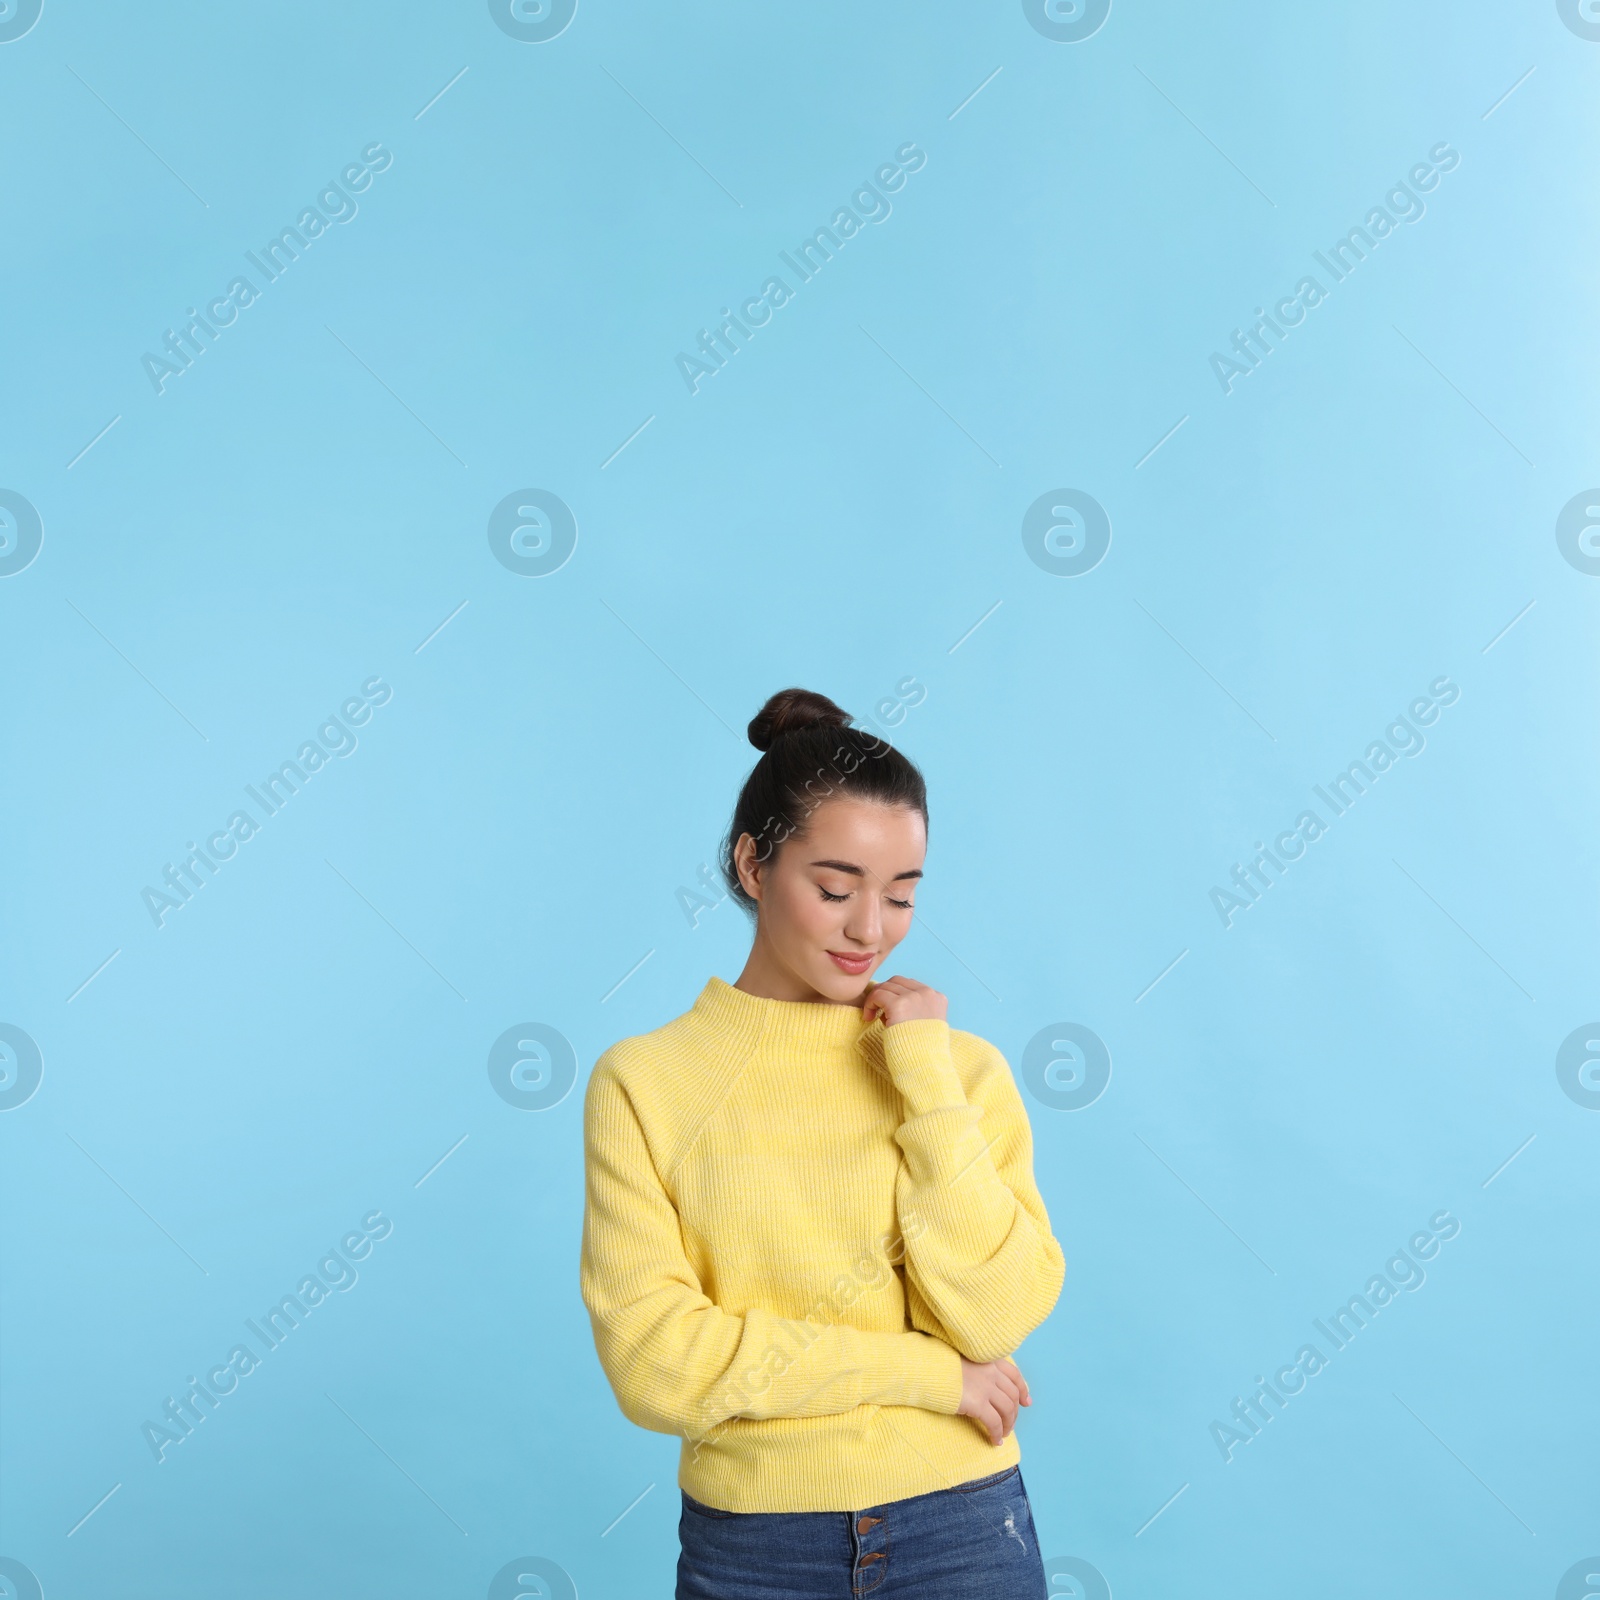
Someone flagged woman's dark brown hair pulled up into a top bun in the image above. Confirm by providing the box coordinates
[722,690,928,914]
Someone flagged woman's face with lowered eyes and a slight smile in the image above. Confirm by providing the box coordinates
[734,795,928,1003]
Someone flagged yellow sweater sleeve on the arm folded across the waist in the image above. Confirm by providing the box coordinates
[579,1061,962,1438]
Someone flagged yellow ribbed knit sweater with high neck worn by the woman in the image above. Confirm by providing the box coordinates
[579,978,1066,1512]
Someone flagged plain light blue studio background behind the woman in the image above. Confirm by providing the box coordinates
[0,0,1600,1600]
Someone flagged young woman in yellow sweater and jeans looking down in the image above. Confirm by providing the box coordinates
[581,690,1066,1600]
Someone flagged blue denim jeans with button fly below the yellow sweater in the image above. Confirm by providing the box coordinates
[675,1467,1045,1600]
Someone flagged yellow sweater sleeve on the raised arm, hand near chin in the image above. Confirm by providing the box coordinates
[883,1018,1067,1362]
